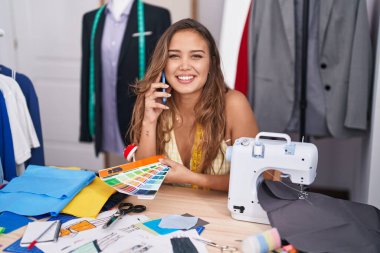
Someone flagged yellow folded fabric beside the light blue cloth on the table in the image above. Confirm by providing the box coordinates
[56,167,116,218]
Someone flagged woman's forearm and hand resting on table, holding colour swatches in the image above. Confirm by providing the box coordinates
[160,158,230,191]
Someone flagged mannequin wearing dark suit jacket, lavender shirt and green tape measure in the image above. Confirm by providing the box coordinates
[79,0,170,158]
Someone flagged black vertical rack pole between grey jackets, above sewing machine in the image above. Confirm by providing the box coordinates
[300,0,310,142]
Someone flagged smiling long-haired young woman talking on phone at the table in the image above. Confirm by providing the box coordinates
[130,19,258,191]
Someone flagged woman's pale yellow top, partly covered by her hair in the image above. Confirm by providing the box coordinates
[165,130,230,175]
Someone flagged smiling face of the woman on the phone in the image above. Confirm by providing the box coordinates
[165,30,210,95]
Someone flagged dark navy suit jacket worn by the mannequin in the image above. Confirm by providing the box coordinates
[79,1,170,154]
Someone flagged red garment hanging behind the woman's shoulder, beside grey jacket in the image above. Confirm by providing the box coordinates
[235,2,252,96]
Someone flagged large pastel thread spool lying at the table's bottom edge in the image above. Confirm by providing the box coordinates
[242,228,281,253]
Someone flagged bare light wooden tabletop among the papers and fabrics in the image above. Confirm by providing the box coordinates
[0,185,270,252]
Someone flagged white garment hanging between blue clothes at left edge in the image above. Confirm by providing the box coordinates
[0,74,40,165]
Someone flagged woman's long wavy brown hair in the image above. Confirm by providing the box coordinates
[129,19,228,173]
